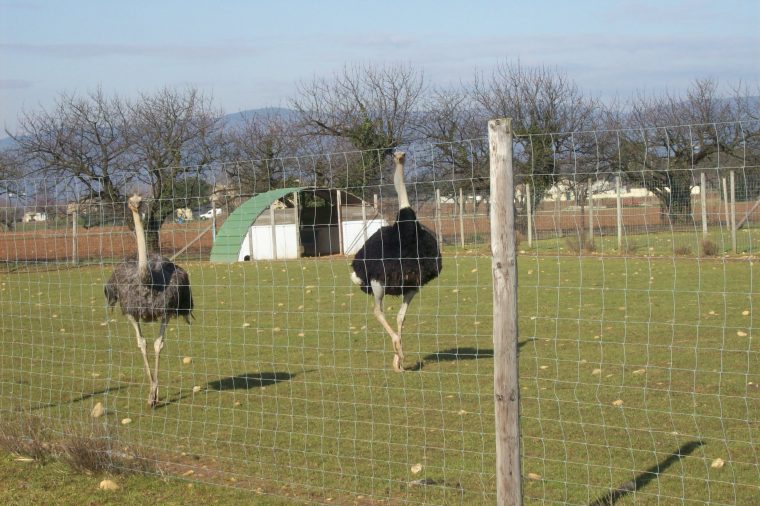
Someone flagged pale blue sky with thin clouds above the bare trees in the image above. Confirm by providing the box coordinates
[0,0,760,136]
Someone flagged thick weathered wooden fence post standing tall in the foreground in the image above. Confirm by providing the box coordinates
[488,119,522,506]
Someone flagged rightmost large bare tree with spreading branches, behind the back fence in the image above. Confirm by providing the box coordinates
[611,79,760,223]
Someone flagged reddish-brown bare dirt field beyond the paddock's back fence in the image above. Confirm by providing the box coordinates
[0,201,760,262]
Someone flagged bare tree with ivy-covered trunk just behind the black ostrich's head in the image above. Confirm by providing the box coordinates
[292,65,425,186]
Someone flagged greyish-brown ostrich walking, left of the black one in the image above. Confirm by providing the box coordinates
[104,195,193,407]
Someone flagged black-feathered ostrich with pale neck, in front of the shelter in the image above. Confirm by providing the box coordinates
[351,152,442,371]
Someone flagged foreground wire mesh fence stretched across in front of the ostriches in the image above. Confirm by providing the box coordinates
[0,123,760,504]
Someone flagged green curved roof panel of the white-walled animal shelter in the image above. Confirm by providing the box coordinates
[210,186,306,262]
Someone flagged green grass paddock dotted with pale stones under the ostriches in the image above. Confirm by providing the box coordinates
[0,248,760,504]
